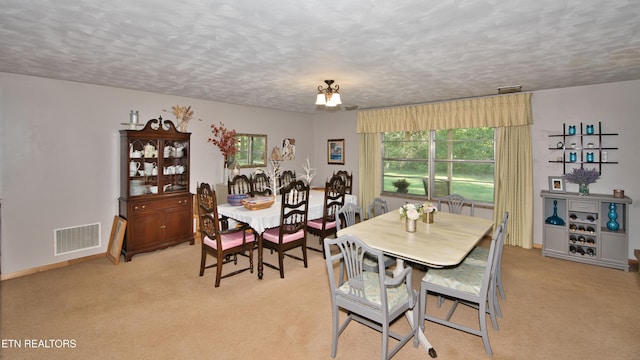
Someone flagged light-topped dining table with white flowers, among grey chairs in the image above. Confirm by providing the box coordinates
[338,210,493,358]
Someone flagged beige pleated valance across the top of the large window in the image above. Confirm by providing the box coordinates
[357,93,533,133]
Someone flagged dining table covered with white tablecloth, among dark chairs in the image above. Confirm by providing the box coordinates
[218,188,357,279]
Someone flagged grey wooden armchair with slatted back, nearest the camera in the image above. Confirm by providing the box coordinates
[324,235,419,360]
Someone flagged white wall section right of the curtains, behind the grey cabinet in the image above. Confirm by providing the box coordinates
[532,80,640,258]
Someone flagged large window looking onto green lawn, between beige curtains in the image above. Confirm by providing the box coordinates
[382,128,495,204]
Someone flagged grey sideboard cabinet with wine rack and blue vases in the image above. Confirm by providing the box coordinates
[540,191,632,271]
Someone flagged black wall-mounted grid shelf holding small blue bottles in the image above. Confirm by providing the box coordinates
[549,122,618,174]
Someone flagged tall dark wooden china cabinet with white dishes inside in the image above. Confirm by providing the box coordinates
[118,117,194,261]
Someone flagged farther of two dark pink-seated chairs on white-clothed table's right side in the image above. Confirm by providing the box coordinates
[307,175,345,252]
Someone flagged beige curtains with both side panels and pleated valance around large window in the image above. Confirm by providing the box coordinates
[357,93,533,249]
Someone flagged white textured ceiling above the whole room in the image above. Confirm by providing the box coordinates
[0,0,640,112]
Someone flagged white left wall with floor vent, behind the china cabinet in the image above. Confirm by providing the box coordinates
[0,73,314,274]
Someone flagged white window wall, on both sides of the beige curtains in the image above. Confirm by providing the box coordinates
[314,80,640,258]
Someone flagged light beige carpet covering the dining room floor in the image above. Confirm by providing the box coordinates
[0,237,640,360]
